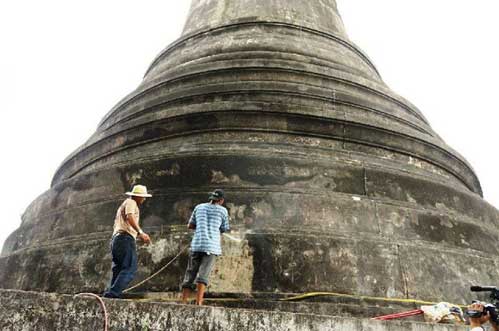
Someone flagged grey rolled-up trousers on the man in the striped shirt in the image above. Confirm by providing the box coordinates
[182,252,217,290]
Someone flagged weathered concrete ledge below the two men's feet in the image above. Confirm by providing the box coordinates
[0,290,468,331]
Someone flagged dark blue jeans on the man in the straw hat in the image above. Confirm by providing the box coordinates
[104,234,137,298]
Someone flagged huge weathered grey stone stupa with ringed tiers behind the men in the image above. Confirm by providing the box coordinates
[0,0,499,303]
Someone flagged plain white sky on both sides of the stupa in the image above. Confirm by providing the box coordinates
[0,0,499,252]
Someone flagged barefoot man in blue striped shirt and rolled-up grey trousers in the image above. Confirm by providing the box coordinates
[182,189,230,305]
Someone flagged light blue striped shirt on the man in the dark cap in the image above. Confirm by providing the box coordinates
[189,202,230,255]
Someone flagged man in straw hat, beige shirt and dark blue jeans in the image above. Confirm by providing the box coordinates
[103,185,152,298]
